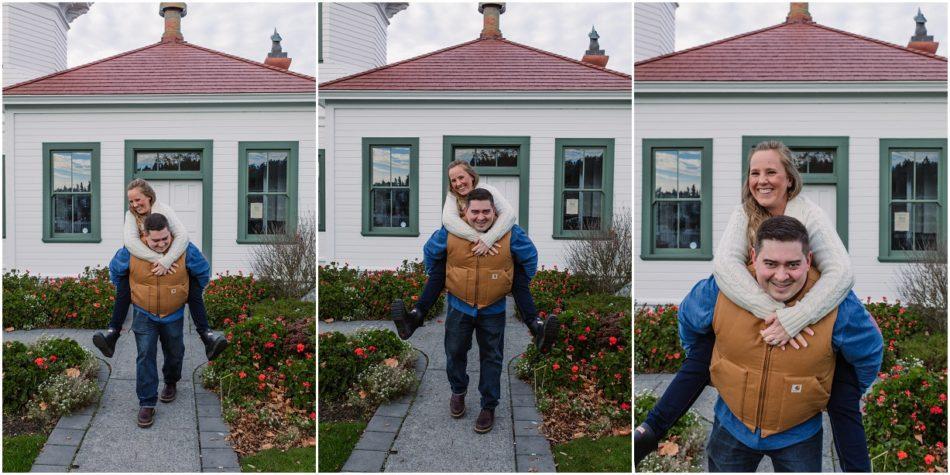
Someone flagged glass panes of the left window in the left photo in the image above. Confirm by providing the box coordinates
[50,151,92,235]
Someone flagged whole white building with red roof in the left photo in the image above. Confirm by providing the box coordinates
[3,4,317,276]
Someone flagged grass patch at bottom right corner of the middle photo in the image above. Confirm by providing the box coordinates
[551,436,632,473]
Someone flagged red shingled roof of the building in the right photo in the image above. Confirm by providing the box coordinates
[634,22,947,81]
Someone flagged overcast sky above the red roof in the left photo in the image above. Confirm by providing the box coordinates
[67,2,317,76]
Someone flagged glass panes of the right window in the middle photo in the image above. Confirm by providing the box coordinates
[561,147,606,231]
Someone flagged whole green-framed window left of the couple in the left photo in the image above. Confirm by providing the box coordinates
[43,143,101,242]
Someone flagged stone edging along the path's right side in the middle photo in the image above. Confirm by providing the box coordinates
[508,356,557,472]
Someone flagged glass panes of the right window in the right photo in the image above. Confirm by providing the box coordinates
[889,150,940,251]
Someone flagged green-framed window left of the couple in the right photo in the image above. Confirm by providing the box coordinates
[640,139,713,260]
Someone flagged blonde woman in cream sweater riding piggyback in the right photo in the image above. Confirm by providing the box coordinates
[634,141,871,472]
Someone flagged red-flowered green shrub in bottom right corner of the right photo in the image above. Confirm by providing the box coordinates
[863,360,947,472]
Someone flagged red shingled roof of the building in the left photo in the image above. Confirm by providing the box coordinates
[3,42,316,96]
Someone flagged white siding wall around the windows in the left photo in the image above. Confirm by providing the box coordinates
[3,105,317,276]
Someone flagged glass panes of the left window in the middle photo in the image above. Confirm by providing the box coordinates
[370,146,411,228]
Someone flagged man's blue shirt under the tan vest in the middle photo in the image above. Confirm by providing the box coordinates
[423,225,538,317]
